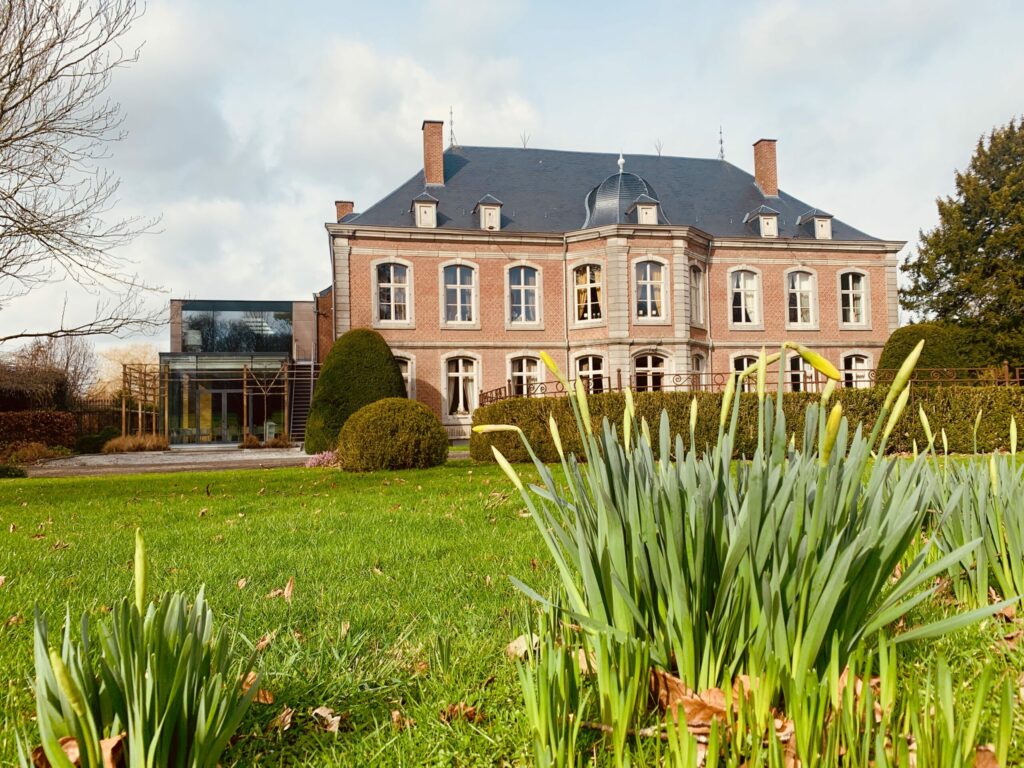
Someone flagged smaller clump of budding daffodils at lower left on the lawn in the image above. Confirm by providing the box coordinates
[18,532,259,768]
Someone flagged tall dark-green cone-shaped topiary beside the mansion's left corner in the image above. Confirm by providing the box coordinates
[305,328,406,454]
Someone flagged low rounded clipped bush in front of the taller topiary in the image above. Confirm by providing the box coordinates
[338,397,449,472]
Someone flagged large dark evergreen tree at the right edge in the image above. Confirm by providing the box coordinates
[901,119,1024,359]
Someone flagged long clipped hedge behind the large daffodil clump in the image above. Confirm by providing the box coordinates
[469,386,1024,462]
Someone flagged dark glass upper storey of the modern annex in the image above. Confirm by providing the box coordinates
[181,301,292,354]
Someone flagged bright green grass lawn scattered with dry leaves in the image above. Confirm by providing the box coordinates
[0,462,1024,766]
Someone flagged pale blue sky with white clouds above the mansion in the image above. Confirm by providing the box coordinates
[0,0,1024,349]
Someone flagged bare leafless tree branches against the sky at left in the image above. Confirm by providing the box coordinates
[0,0,157,343]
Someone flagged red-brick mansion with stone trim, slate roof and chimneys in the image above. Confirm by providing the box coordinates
[316,120,903,437]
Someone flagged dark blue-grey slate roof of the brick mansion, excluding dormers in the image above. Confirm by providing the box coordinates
[344,146,877,241]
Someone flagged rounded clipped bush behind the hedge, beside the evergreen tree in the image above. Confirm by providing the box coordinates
[879,323,996,371]
